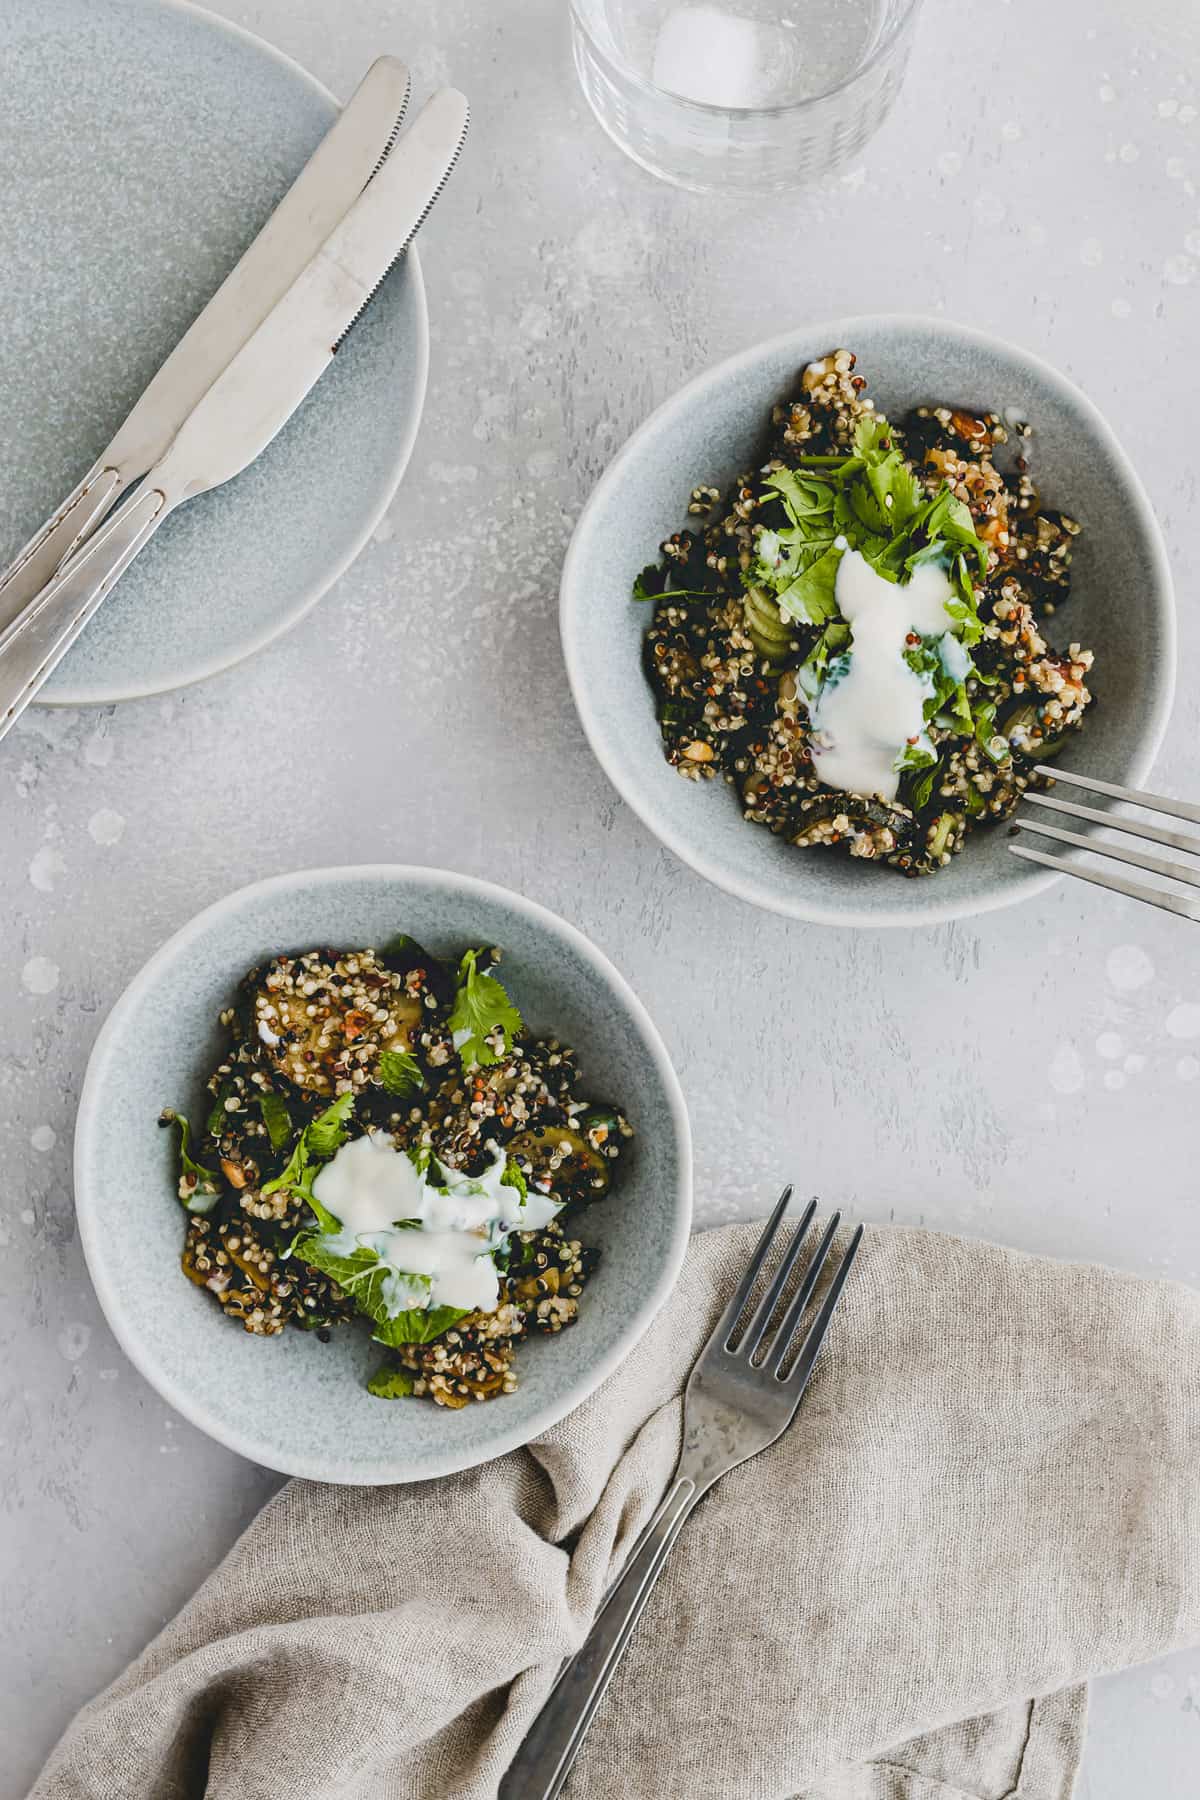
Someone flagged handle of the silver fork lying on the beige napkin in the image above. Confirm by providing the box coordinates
[498,1476,702,1800]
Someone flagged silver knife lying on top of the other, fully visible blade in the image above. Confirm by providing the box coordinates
[0,88,468,736]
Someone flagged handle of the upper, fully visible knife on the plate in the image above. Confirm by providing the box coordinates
[0,488,173,738]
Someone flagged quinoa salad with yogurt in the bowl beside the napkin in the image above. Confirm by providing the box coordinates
[160,936,631,1408]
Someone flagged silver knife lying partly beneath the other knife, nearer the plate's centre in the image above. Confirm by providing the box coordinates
[0,56,412,632]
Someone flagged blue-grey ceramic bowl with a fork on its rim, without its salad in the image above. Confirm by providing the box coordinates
[561,317,1175,925]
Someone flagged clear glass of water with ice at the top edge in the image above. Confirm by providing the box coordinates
[569,0,921,194]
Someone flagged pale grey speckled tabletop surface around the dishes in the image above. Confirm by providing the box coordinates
[0,0,1200,1800]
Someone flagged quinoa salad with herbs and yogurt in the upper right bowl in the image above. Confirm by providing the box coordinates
[633,349,1092,875]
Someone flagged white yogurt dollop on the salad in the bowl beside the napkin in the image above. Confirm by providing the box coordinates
[313,1132,560,1312]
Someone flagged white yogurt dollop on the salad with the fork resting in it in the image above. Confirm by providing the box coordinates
[810,549,970,799]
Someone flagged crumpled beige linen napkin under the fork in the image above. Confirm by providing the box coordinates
[34,1226,1200,1800]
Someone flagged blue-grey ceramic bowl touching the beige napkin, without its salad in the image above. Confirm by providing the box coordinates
[76,866,691,1485]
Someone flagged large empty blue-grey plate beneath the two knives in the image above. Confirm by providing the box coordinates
[0,0,428,706]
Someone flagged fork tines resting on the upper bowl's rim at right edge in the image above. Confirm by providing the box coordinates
[1009,763,1200,920]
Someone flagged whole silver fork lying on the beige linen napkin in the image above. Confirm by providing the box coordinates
[498,1186,862,1800]
